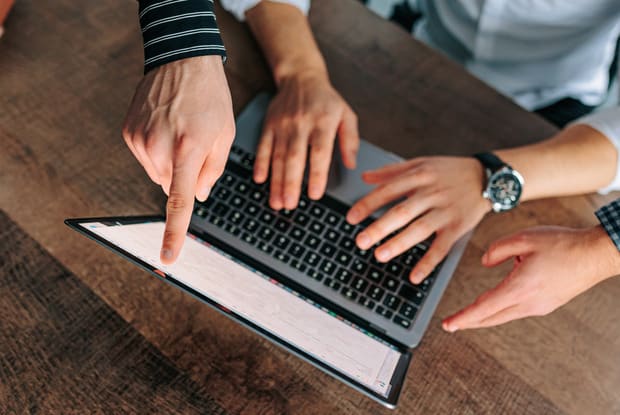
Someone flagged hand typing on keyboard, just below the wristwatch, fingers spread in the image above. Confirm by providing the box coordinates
[347,157,491,284]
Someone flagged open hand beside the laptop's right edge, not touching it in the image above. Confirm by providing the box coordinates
[443,226,620,332]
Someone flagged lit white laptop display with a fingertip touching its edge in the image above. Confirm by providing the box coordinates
[75,220,408,404]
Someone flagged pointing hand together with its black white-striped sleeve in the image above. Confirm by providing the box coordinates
[123,0,235,263]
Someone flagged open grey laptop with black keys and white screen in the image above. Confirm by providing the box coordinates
[66,94,469,408]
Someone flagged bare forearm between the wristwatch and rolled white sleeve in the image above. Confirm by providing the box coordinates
[496,124,618,200]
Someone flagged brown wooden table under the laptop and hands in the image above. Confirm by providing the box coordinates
[0,0,620,414]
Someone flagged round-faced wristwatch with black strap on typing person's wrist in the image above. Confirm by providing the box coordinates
[474,153,523,212]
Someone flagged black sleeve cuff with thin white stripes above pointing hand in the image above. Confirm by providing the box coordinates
[139,0,226,73]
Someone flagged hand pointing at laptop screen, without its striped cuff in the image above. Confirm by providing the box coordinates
[123,56,235,264]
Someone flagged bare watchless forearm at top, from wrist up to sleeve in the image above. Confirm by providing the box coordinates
[245,1,327,85]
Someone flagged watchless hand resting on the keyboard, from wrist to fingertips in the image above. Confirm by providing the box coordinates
[254,73,359,210]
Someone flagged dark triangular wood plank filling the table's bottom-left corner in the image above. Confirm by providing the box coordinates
[0,210,225,414]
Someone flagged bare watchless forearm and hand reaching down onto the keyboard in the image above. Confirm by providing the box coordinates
[234,0,359,209]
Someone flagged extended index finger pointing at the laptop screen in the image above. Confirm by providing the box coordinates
[160,150,202,264]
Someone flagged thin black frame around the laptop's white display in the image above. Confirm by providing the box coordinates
[65,215,412,409]
